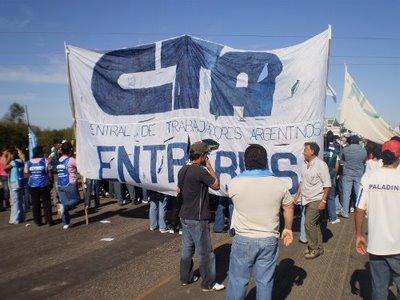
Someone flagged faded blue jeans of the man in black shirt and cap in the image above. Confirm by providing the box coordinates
[180,219,216,289]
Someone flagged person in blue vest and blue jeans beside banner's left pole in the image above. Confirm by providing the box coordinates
[57,142,79,229]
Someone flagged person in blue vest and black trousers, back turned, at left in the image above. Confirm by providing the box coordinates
[25,146,53,226]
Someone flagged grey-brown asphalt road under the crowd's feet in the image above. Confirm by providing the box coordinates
[0,199,396,299]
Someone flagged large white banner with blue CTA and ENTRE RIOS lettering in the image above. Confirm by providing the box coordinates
[66,29,331,195]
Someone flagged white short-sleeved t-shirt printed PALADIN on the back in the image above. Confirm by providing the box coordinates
[356,167,400,255]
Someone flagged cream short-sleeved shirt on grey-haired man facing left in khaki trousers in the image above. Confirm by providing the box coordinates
[301,157,332,205]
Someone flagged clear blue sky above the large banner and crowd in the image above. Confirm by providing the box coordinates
[0,0,400,128]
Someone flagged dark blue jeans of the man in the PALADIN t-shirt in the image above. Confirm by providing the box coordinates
[369,254,400,300]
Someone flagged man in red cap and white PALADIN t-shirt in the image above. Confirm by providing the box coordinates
[355,140,400,299]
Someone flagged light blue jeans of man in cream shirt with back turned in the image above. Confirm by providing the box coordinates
[226,235,279,300]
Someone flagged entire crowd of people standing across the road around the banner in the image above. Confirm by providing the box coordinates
[0,131,400,299]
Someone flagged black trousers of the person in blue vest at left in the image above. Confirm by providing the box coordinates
[29,185,53,225]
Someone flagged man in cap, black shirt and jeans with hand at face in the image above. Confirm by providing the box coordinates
[178,141,225,291]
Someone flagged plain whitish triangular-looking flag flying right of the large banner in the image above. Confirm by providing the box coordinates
[340,67,399,144]
